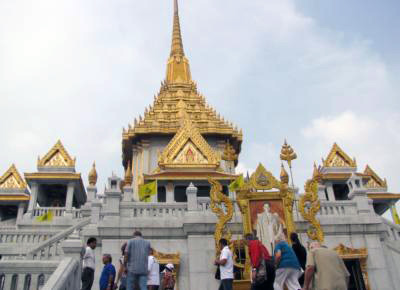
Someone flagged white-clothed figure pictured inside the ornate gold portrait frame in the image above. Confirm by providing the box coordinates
[256,203,283,255]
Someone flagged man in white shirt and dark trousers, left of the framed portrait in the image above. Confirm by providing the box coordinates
[215,239,233,290]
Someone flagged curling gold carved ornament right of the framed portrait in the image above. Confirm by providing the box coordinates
[299,177,324,243]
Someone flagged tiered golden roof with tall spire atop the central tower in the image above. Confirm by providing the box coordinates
[122,0,243,168]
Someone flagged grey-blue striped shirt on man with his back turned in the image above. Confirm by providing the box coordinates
[125,237,150,275]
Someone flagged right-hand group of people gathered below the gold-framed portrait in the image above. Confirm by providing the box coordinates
[215,233,350,290]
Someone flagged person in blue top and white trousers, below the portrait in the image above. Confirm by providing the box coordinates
[274,234,301,290]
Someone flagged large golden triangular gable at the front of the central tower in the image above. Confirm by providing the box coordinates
[158,114,219,168]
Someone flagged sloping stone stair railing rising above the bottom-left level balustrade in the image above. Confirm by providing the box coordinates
[27,218,90,260]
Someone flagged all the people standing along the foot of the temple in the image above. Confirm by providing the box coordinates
[82,231,350,290]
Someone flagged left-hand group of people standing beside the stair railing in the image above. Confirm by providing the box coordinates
[81,231,175,290]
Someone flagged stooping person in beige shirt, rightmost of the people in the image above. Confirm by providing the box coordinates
[303,242,350,290]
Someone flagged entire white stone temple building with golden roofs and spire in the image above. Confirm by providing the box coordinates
[0,0,400,290]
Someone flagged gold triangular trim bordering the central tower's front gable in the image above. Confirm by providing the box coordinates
[158,112,219,168]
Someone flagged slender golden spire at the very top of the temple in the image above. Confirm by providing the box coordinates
[167,0,192,83]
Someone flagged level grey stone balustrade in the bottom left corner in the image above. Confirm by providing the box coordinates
[0,260,58,290]
